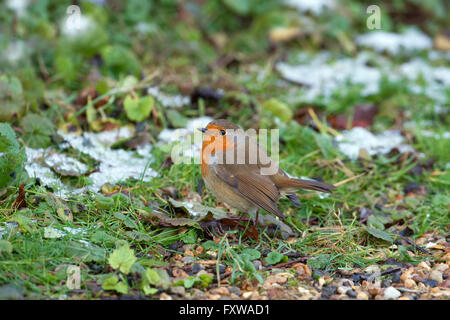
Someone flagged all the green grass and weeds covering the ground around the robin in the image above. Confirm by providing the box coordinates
[0,1,450,299]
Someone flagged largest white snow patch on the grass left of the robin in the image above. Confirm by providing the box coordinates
[25,127,157,197]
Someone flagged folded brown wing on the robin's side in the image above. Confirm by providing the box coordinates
[213,164,285,220]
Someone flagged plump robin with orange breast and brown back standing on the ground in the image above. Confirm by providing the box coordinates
[199,119,336,225]
